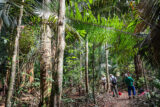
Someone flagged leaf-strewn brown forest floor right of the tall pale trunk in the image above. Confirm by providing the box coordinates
[63,88,149,107]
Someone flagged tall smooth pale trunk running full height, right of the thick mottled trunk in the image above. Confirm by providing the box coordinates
[57,0,65,107]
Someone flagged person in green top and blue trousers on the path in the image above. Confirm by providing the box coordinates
[125,73,136,99]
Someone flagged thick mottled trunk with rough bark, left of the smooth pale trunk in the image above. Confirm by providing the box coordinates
[40,0,52,106]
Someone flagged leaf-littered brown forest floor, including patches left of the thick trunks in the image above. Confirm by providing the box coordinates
[0,91,149,107]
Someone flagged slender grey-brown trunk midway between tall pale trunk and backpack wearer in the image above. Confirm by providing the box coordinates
[85,37,89,94]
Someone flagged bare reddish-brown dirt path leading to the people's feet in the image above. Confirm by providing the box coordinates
[104,92,134,107]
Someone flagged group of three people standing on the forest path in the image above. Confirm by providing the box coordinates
[101,73,136,99]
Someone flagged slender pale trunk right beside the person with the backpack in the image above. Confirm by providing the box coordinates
[105,43,111,92]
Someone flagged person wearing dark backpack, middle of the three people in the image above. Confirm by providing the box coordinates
[110,74,119,97]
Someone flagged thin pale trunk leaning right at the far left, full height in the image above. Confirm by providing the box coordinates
[6,0,24,107]
